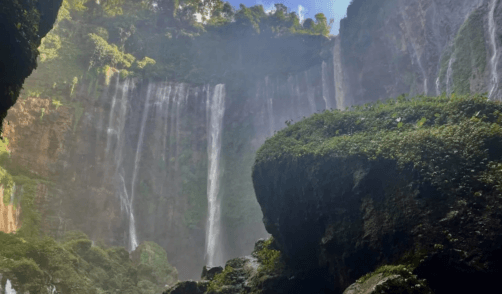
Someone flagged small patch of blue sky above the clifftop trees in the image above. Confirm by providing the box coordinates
[223,0,351,35]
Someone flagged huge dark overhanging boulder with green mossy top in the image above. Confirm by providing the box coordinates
[253,95,502,293]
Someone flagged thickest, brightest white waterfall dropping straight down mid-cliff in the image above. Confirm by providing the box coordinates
[206,84,225,266]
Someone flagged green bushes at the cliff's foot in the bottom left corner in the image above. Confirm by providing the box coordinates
[0,231,176,293]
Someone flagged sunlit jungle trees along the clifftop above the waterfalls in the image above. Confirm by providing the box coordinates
[23,0,331,100]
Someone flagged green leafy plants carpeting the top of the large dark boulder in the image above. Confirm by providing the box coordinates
[253,95,502,194]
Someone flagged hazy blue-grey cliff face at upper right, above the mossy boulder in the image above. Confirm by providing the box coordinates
[335,0,502,105]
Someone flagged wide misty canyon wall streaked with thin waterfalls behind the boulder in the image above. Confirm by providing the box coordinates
[4,0,502,279]
